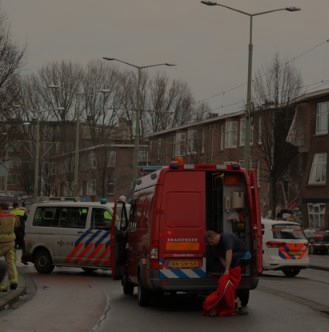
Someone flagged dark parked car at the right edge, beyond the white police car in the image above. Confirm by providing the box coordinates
[305,228,329,255]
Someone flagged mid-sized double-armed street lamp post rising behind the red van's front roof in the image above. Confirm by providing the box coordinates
[103,57,176,184]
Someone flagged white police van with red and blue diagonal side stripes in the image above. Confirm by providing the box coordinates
[22,201,129,273]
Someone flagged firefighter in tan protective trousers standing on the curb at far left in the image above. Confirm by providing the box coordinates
[0,203,19,291]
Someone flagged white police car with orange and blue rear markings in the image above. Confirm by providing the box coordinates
[262,219,310,277]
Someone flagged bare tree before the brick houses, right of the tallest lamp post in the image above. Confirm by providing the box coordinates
[254,54,302,218]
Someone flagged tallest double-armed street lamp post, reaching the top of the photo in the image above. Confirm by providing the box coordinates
[201,1,300,170]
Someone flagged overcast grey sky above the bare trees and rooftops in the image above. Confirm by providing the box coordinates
[0,0,329,114]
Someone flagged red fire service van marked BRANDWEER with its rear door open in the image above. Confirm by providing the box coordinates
[111,161,262,306]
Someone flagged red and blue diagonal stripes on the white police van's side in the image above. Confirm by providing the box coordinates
[64,229,111,267]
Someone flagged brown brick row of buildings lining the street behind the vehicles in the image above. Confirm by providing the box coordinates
[0,89,329,228]
